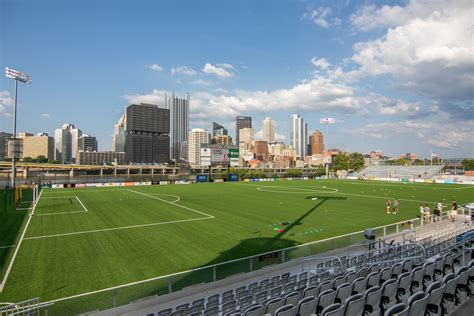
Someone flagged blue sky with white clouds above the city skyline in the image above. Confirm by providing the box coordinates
[0,0,474,157]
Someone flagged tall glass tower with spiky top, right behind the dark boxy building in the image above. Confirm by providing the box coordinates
[164,92,189,161]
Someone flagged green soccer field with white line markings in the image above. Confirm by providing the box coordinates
[0,180,474,310]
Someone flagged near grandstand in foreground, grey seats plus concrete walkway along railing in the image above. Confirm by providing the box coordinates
[90,213,474,316]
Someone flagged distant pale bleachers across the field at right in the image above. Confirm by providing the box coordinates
[354,165,444,179]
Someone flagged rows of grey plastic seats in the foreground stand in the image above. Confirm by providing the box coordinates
[151,227,474,316]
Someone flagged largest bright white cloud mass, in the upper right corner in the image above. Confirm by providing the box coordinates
[351,0,474,101]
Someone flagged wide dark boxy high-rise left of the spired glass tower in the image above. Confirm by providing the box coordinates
[125,103,170,163]
